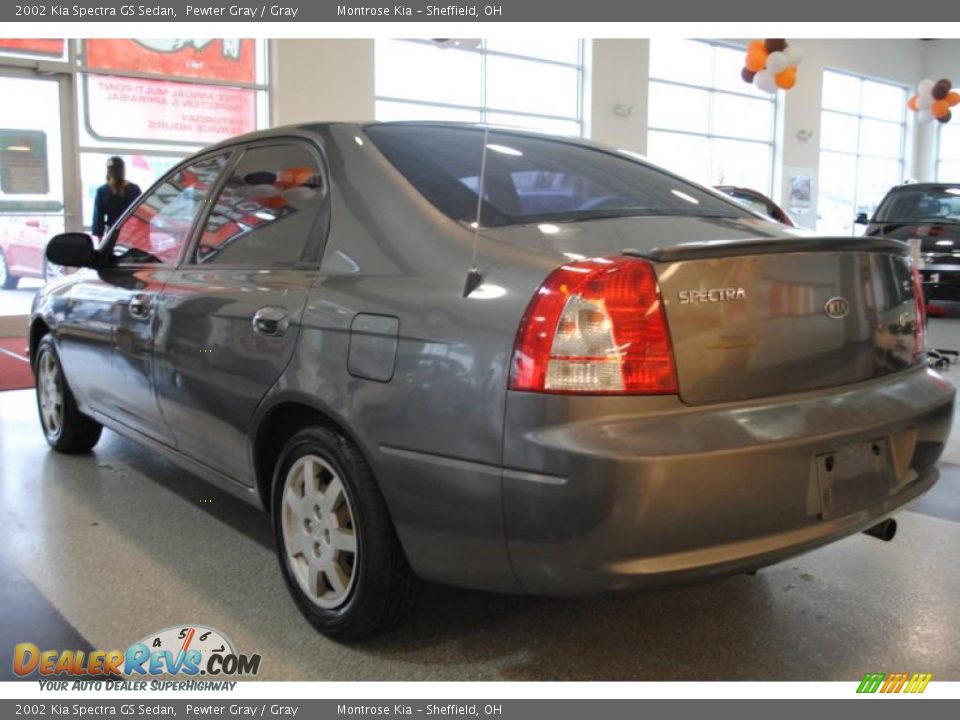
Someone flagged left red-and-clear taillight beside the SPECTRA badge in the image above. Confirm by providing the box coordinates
[510,257,677,394]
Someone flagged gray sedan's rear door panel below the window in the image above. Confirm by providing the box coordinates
[154,267,315,485]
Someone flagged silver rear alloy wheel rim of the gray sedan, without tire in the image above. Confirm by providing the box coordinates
[281,455,359,609]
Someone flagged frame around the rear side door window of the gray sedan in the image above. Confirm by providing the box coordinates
[185,134,333,270]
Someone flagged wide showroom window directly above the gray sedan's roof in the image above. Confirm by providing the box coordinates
[376,38,583,135]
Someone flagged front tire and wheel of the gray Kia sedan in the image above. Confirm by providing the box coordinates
[34,335,103,454]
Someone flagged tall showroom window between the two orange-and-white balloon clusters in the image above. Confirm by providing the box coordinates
[817,70,907,235]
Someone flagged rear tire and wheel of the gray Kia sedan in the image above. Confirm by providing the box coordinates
[272,427,417,641]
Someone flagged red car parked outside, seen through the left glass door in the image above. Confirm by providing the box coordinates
[0,215,63,290]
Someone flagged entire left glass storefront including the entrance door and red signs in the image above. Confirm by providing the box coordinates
[0,38,269,316]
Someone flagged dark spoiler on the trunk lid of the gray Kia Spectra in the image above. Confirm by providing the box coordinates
[623,237,910,262]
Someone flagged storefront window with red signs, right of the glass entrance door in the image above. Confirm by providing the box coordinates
[78,39,268,233]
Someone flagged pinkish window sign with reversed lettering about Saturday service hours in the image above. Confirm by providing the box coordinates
[87,75,257,145]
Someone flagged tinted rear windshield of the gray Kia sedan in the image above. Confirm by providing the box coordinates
[367,124,752,227]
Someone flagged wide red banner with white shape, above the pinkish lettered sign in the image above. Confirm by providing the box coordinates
[85,38,257,83]
